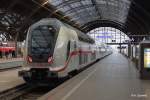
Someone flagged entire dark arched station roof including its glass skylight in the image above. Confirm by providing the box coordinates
[0,0,150,41]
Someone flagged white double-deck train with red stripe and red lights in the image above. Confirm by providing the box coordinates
[18,18,112,83]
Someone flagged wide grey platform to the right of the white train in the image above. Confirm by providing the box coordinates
[39,53,150,100]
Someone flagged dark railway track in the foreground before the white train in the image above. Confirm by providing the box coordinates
[0,80,65,100]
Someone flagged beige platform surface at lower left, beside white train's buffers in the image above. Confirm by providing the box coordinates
[0,69,24,92]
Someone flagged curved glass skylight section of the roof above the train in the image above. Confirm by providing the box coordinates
[49,0,131,26]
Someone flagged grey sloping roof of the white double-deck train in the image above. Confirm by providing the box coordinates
[30,18,95,43]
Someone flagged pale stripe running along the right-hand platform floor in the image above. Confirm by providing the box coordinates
[61,68,97,100]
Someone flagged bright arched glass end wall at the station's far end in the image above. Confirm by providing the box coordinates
[88,27,129,43]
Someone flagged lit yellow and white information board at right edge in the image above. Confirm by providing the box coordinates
[144,48,150,68]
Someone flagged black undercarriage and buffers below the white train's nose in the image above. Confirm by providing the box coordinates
[19,68,59,84]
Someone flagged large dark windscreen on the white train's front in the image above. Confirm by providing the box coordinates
[31,26,56,55]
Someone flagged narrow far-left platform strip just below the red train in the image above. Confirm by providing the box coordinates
[0,58,23,70]
